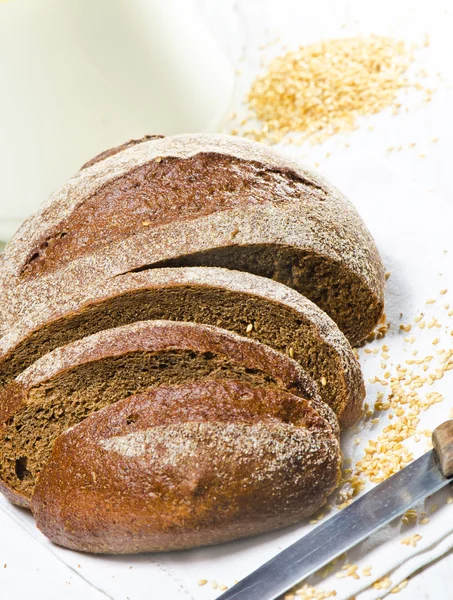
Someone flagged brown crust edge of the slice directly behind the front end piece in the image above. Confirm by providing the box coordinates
[0,321,339,506]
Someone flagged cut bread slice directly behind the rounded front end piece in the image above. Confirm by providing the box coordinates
[0,321,338,506]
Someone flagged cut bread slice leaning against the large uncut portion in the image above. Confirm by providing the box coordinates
[0,267,365,428]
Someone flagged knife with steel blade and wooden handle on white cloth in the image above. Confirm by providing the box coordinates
[217,420,453,600]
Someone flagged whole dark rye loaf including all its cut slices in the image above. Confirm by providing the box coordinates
[0,135,384,553]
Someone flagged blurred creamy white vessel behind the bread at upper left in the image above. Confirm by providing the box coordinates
[0,0,234,239]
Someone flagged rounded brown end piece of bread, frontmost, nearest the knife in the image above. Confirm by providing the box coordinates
[32,380,340,554]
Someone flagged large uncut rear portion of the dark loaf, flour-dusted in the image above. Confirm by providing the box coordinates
[0,134,384,344]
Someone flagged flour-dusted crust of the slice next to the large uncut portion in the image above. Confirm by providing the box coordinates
[0,267,365,428]
